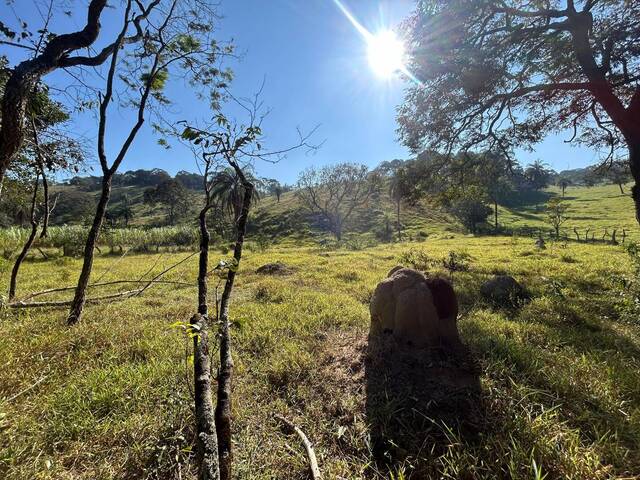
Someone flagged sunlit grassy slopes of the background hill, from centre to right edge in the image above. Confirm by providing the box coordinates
[251,185,640,240]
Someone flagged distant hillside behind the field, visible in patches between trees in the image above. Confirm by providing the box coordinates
[47,177,638,240]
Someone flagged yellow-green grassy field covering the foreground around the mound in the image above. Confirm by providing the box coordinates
[0,232,640,480]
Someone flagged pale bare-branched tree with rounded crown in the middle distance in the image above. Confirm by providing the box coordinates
[296,163,377,241]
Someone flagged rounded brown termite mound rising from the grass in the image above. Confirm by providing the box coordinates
[369,267,462,347]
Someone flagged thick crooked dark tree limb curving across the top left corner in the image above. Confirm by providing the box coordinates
[0,0,160,199]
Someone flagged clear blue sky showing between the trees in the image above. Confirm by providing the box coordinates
[0,0,597,184]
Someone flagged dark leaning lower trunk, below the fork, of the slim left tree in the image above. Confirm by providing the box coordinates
[67,174,113,325]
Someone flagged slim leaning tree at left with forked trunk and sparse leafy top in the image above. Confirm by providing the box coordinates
[67,0,228,325]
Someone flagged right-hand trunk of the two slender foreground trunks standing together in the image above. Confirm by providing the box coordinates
[215,168,253,480]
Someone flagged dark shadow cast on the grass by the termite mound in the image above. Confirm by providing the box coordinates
[365,334,487,478]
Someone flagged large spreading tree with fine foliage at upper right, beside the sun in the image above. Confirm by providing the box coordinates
[398,0,640,222]
